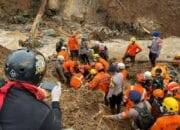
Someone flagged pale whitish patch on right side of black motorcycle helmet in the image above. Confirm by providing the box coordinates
[36,55,46,74]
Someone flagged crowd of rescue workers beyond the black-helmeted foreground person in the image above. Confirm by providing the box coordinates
[56,32,180,130]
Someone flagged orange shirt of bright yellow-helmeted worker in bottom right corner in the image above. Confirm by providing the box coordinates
[151,115,180,130]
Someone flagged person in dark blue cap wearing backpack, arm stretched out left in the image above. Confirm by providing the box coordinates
[103,90,153,130]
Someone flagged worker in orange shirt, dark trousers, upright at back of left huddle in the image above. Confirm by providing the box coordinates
[68,32,79,59]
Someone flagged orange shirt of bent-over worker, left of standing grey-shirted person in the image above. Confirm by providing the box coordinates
[89,72,111,94]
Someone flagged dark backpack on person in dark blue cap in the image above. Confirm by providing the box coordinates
[134,103,154,130]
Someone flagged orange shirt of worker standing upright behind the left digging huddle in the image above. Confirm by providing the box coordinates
[68,36,79,51]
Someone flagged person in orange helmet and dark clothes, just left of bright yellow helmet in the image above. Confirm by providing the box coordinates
[151,89,164,119]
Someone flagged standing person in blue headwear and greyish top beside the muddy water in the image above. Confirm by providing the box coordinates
[148,32,163,67]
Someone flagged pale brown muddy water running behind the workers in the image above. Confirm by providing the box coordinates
[0,29,180,61]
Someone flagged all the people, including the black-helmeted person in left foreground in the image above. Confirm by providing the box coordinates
[0,32,180,130]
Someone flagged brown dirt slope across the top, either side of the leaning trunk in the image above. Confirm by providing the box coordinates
[0,0,180,36]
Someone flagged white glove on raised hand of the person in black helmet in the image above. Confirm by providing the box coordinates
[51,82,61,102]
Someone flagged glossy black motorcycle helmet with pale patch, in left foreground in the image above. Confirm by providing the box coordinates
[4,48,46,85]
